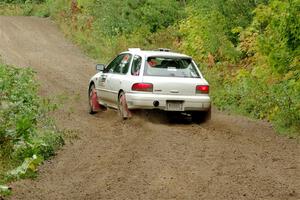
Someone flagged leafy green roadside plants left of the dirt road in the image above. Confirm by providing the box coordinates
[0,63,64,196]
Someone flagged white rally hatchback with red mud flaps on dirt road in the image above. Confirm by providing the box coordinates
[88,48,211,122]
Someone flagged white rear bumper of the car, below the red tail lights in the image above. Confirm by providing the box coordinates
[126,93,211,111]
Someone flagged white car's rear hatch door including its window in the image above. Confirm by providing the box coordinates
[143,56,208,95]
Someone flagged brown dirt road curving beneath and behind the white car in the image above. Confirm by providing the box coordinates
[0,17,300,200]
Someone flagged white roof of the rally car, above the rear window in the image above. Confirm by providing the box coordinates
[122,48,191,58]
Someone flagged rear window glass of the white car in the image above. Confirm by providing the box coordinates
[144,57,200,78]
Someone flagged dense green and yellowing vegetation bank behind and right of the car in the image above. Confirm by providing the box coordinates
[0,0,300,137]
